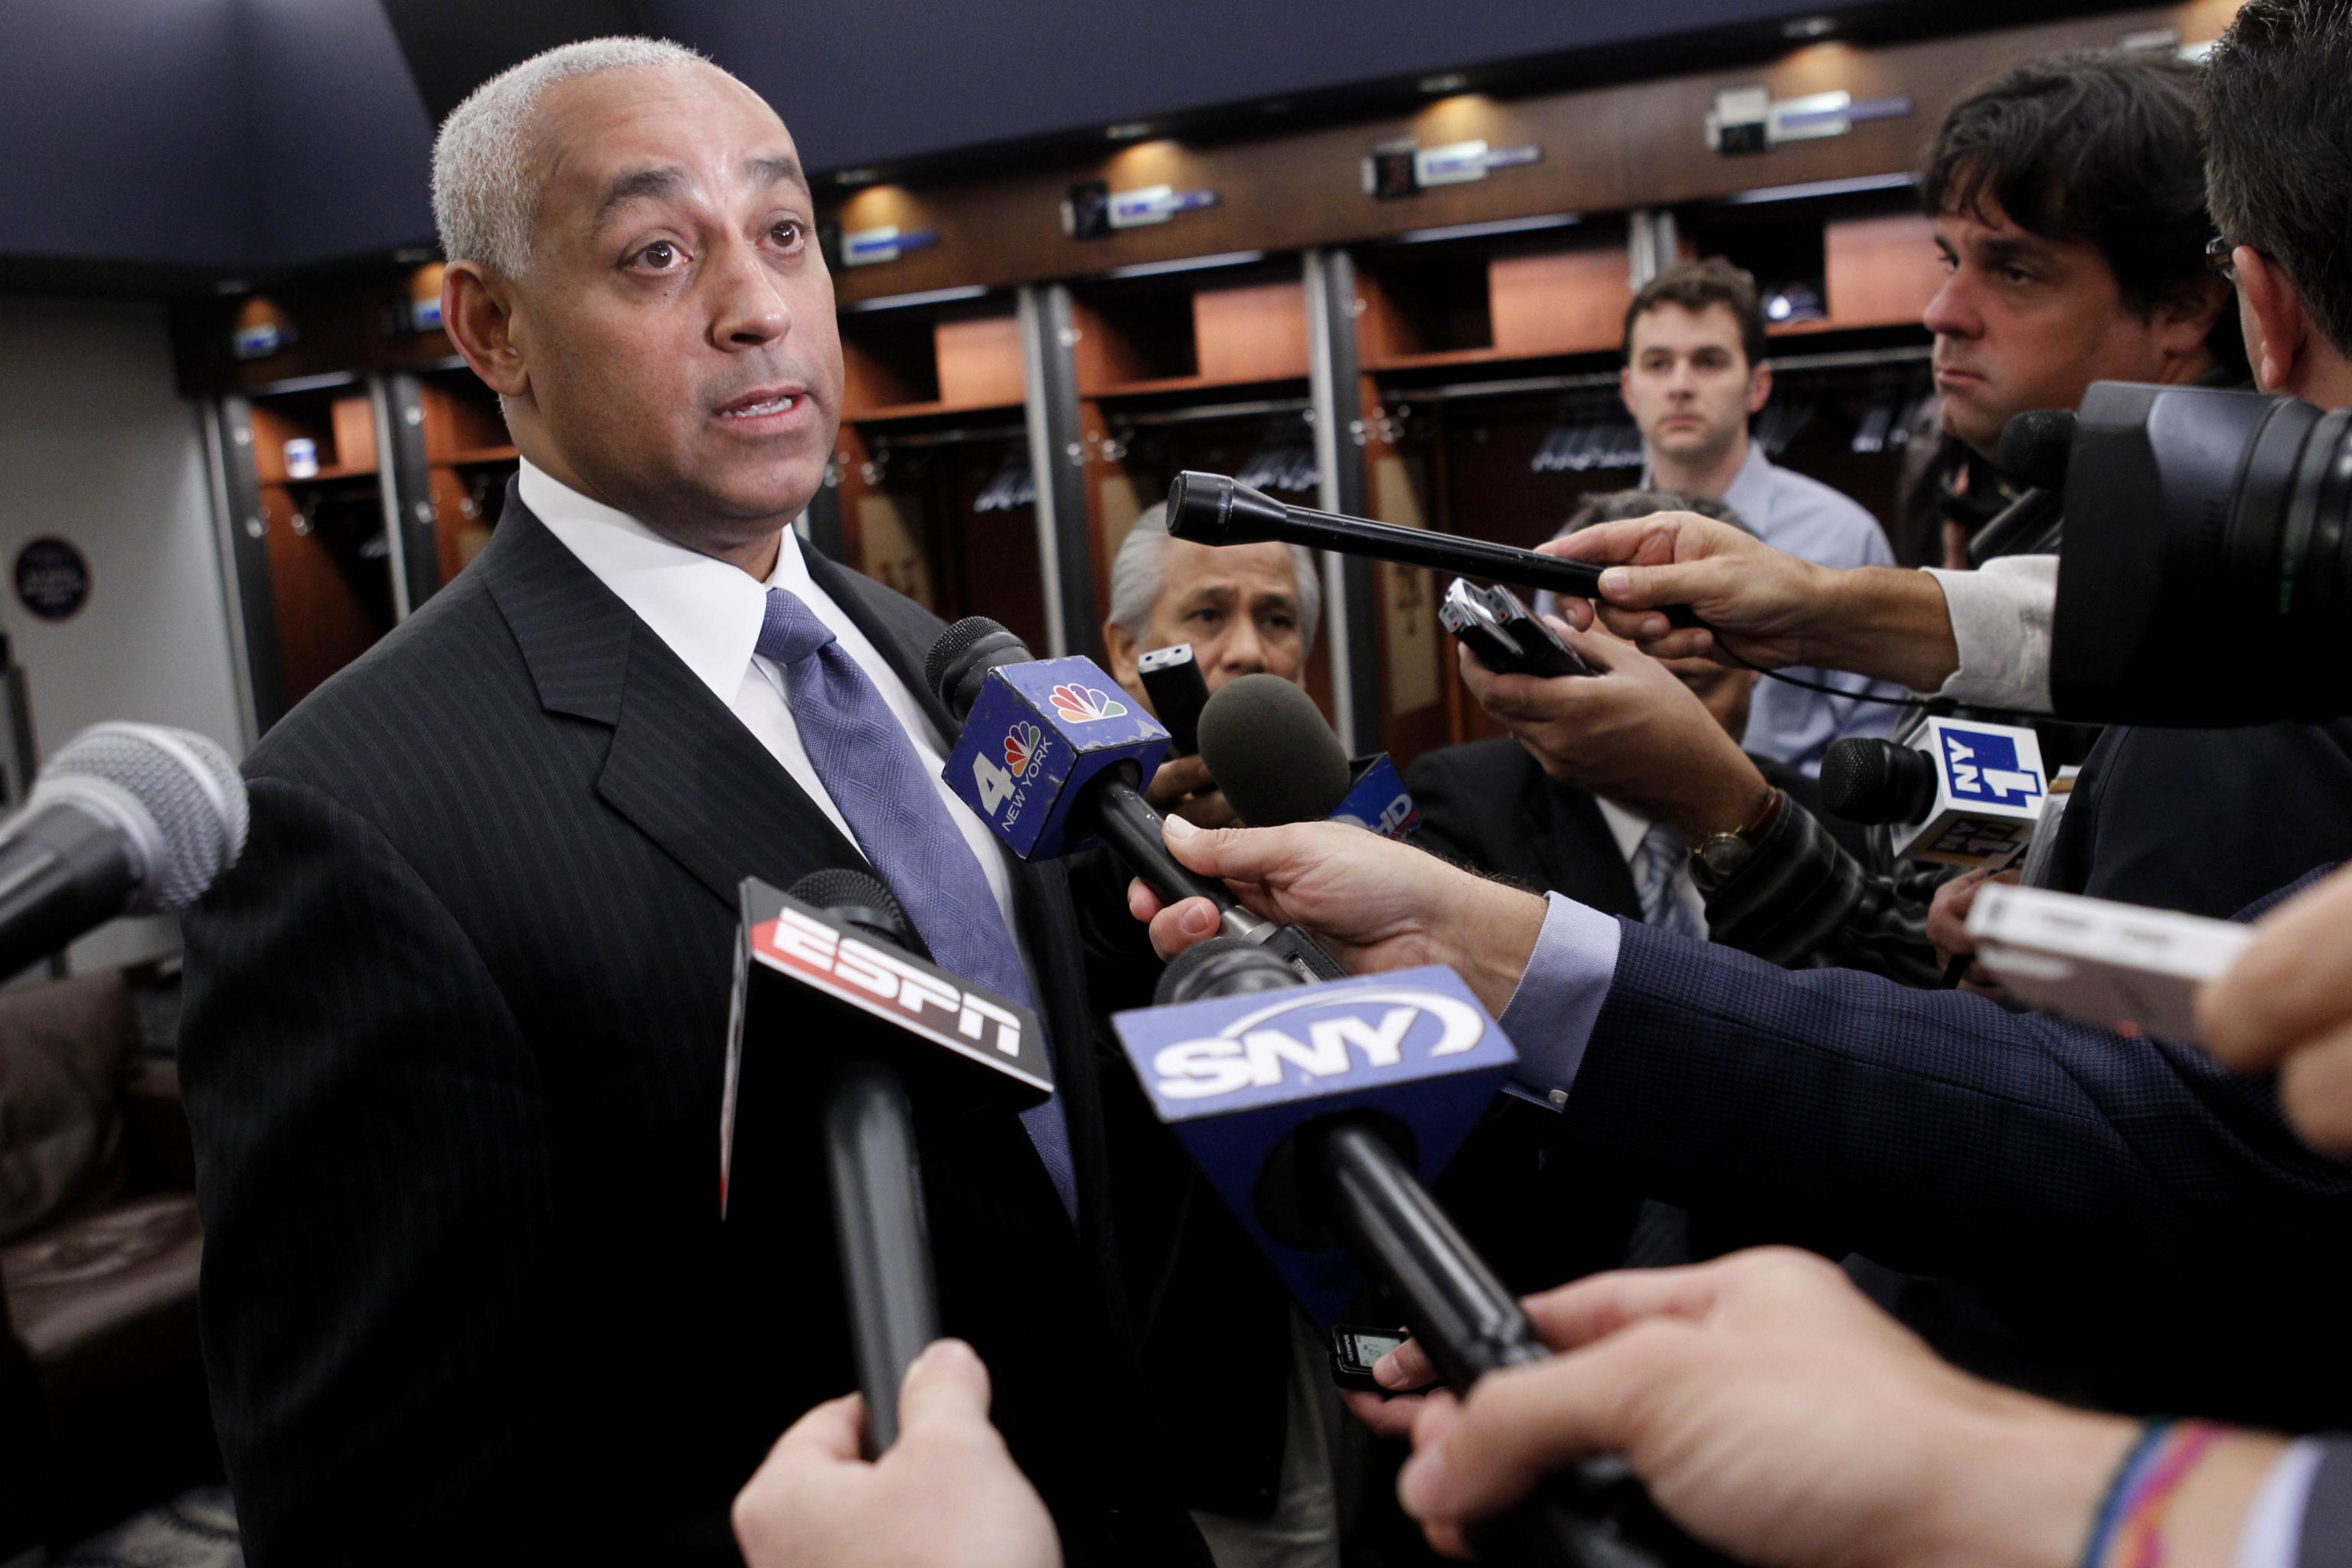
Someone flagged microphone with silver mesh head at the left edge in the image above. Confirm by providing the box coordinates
[0,724,247,978]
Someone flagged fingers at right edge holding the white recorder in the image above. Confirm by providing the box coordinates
[2197,867,2352,1155]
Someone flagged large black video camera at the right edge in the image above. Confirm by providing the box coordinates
[2051,381,2352,727]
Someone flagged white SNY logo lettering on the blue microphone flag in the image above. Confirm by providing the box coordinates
[1152,988,1487,1100]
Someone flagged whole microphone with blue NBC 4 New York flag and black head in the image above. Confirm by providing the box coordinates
[924,616,1343,978]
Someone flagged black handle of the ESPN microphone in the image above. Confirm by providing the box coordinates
[825,1060,939,1460]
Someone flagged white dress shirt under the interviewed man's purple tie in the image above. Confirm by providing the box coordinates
[518,459,1037,949]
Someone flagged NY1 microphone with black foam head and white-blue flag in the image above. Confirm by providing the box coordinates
[1821,720,2049,865]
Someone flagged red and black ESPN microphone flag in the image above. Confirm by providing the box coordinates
[720,877,1054,1218]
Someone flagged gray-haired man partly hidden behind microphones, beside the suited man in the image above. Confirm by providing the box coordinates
[1103,503,1321,828]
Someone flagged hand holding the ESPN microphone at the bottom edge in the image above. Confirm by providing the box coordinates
[733,1340,1060,1568]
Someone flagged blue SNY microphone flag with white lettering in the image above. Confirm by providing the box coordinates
[1112,964,1520,1326]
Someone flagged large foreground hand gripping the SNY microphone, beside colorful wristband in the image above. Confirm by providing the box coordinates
[1380,1248,2173,1568]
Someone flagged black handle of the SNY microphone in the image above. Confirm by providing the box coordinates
[1301,1116,1722,1568]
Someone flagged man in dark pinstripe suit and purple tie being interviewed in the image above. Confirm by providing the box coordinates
[181,40,1202,1568]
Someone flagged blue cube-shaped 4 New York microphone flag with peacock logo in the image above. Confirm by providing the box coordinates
[941,658,1169,861]
